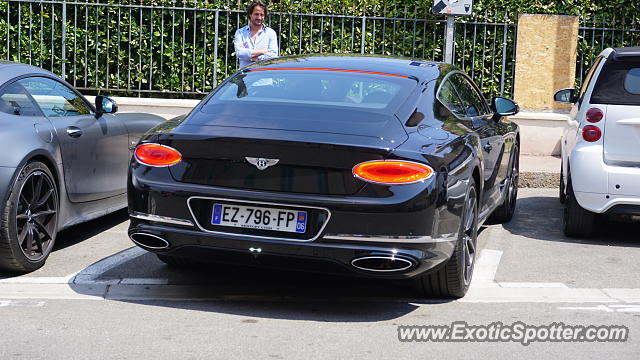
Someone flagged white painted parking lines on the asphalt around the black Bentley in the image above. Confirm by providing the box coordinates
[0,247,640,304]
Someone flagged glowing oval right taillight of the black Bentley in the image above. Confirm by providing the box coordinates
[353,160,433,185]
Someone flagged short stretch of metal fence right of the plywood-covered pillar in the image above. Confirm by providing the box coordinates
[576,16,640,86]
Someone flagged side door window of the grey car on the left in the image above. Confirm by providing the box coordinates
[19,77,91,117]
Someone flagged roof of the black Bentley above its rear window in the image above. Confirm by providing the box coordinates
[245,54,442,82]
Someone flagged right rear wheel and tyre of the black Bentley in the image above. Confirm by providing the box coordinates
[417,179,478,298]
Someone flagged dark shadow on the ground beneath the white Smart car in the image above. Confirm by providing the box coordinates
[503,197,640,247]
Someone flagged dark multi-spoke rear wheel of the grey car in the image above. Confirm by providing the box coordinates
[0,161,59,272]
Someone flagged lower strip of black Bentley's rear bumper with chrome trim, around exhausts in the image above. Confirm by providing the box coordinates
[129,218,457,279]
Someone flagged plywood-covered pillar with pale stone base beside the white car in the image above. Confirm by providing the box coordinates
[513,14,579,155]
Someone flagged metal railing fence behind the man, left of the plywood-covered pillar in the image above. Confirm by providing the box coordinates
[0,0,516,98]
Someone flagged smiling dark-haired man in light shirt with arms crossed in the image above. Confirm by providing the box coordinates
[233,0,278,68]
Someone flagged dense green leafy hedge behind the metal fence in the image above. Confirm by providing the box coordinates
[0,0,640,98]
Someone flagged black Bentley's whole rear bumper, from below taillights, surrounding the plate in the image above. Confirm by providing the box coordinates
[128,163,466,279]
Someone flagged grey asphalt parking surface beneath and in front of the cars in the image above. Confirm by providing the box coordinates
[0,189,640,359]
